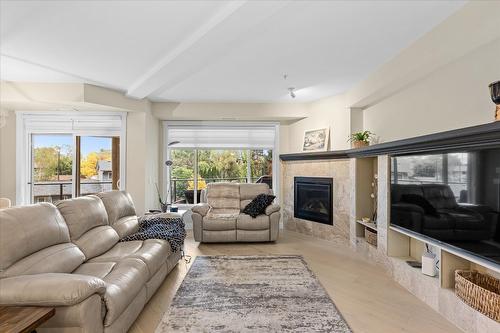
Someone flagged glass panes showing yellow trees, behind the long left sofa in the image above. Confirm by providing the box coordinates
[30,134,120,203]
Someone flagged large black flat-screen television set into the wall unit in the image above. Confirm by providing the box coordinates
[391,146,500,264]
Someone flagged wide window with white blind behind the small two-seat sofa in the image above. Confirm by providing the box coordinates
[164,122,279,204]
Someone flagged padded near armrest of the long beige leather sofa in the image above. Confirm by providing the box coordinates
[0,273,106,306]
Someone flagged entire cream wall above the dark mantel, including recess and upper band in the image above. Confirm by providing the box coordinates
[288,1,500,147]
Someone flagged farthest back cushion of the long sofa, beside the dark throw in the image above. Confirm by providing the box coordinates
[97,191,139,238]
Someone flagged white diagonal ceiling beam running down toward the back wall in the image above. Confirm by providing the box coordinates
[127,1,289,98]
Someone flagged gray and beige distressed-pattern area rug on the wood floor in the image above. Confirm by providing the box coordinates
[156,256,351,333]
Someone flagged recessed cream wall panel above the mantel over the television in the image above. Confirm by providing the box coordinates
[363,38,500,142]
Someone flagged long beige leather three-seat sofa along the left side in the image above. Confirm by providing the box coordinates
[0,191,181,333]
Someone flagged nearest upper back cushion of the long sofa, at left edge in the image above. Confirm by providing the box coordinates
[0,203,70,271]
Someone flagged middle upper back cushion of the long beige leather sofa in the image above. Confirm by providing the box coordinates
[56,195,108,240]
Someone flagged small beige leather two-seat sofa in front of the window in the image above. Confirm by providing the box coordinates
[192,183,280,243]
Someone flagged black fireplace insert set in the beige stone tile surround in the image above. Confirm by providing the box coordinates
[293,177,333,225]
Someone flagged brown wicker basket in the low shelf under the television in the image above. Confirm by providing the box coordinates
[455,270,500,322]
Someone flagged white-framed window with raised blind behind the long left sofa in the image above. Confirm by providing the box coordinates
[16,112,126,204]
